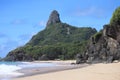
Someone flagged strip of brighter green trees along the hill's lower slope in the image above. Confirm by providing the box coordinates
[13,41,87,60]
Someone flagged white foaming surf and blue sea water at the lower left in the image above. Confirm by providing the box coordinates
[0,62,55,80]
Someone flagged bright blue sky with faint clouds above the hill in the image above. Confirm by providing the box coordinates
[0,0,120,57]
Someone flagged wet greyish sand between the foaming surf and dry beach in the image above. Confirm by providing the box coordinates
[19,61,89,77]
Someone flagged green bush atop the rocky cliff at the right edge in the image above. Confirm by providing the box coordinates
[110,7,120,25]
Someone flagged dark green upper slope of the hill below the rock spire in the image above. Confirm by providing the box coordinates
[28,23,96,46]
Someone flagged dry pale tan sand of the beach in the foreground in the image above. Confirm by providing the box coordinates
[14,62,120,80]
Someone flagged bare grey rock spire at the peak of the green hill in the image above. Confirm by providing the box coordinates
[46,10,61,26]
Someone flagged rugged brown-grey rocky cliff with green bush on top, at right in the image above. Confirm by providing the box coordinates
[77,7,120,63]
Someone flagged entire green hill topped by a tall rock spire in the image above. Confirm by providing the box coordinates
[5,10,97,61]
